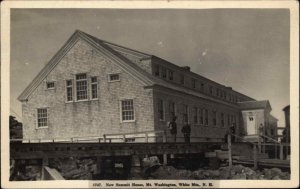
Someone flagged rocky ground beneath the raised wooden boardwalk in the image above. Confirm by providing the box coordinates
[14,158,290,180]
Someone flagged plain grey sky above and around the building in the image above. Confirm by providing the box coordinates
[10,9,290,126]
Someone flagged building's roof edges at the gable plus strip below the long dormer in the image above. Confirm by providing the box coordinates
[18,30,251,106]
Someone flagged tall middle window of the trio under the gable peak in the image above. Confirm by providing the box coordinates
[76,74,88,100]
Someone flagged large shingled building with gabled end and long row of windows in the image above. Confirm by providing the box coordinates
[18,31,278,141]
